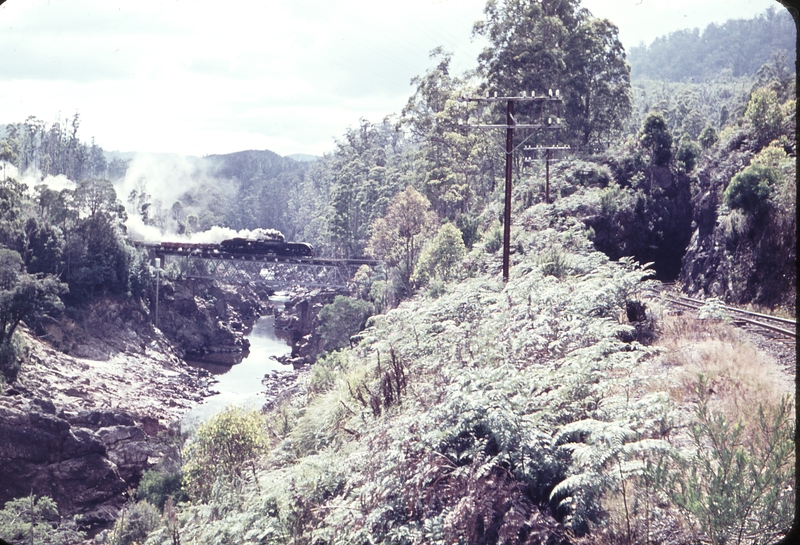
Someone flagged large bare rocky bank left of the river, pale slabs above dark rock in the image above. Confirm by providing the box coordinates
[0,299,211,528]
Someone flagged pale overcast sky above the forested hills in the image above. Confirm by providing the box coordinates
[0,0,784,155]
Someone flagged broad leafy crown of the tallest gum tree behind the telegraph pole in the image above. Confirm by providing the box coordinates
[473,0,631,148]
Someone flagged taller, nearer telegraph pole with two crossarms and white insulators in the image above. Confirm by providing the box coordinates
[460,89,561,282]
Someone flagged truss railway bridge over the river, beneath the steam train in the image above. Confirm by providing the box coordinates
[142,243,377,290]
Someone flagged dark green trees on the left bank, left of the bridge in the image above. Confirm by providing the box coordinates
[0,172,153,381]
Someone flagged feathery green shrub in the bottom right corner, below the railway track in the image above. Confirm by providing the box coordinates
[670,376,795,545]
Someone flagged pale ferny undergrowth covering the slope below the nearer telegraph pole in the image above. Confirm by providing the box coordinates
[134,219,794,545]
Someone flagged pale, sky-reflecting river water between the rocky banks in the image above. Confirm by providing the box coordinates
[181,298,293,430]
